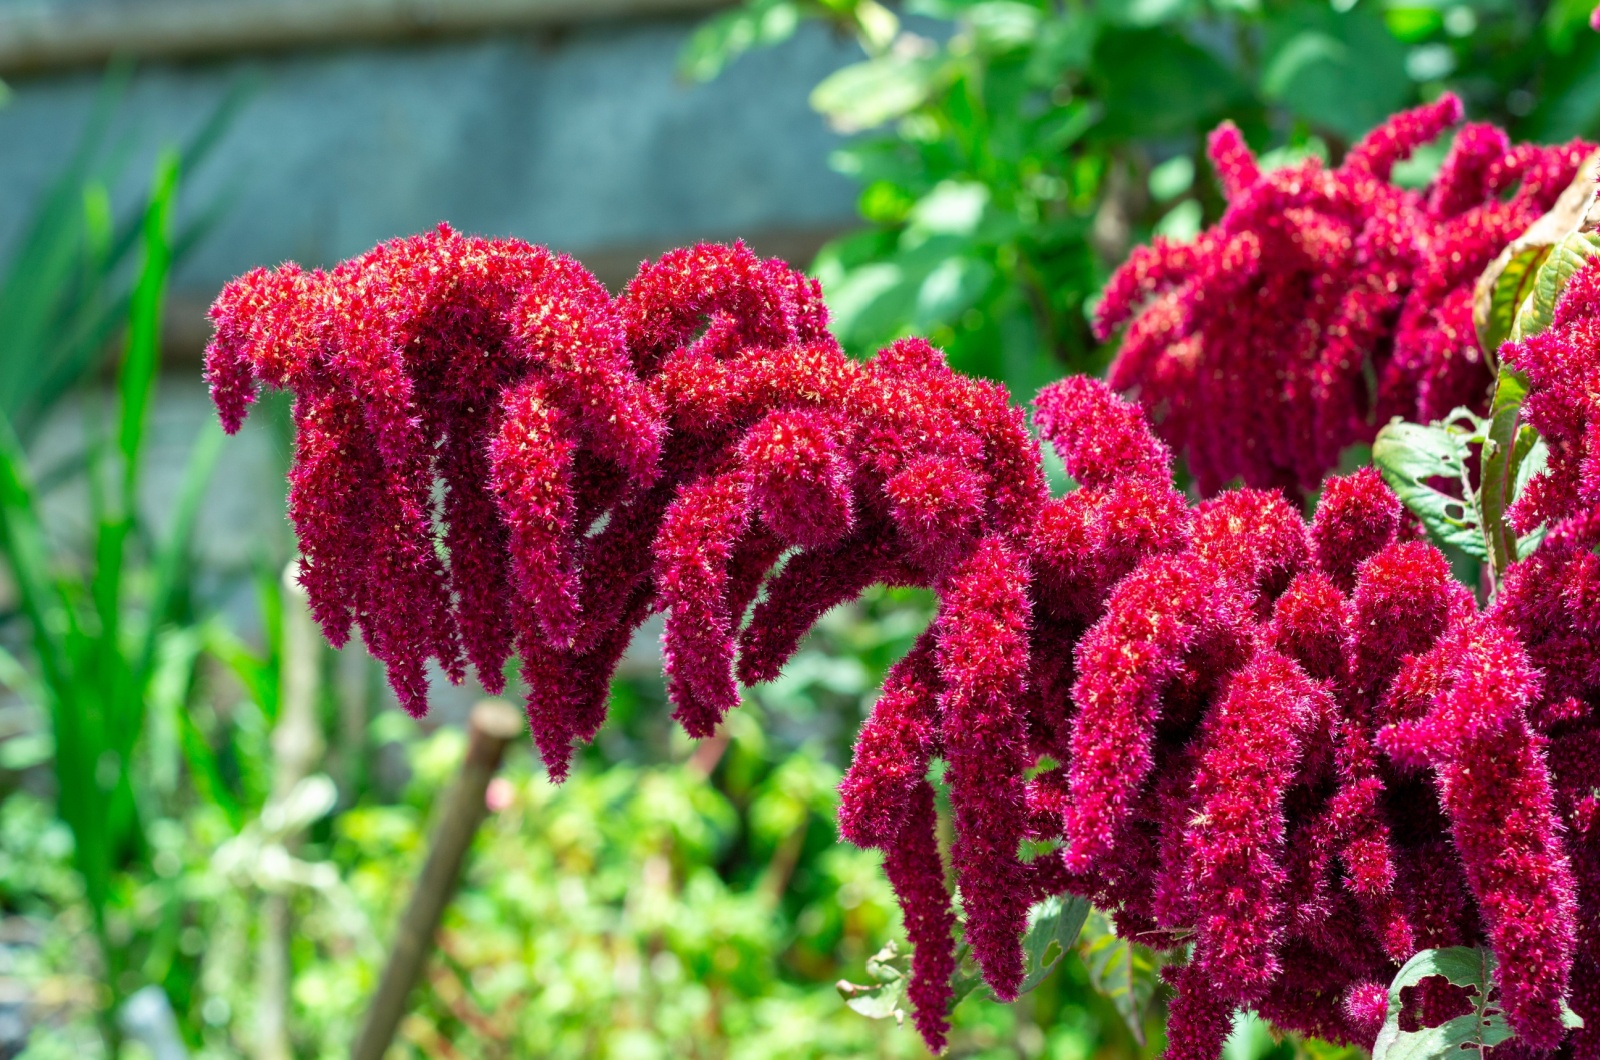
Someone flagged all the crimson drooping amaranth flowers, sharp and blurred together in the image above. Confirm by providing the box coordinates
[206,108,1600,1060]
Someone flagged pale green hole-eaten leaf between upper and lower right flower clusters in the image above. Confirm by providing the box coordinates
[1373,408,1488,559]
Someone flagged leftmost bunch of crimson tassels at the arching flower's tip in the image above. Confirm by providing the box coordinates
[206,226,662,714]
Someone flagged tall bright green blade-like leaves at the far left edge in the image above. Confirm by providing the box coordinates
[0,140,221,1049]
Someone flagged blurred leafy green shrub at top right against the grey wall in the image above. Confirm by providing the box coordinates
[683,0,1600,395]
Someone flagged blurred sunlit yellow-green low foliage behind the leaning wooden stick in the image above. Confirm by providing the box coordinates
[9,592,1164,1060]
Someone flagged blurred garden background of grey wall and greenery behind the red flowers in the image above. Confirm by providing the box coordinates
[0,0,1600,1060]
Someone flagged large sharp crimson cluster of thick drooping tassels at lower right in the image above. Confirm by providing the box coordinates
[1026,392,1574,1060]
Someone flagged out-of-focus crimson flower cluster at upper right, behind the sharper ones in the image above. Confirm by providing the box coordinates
[1096,94,1590,495]
